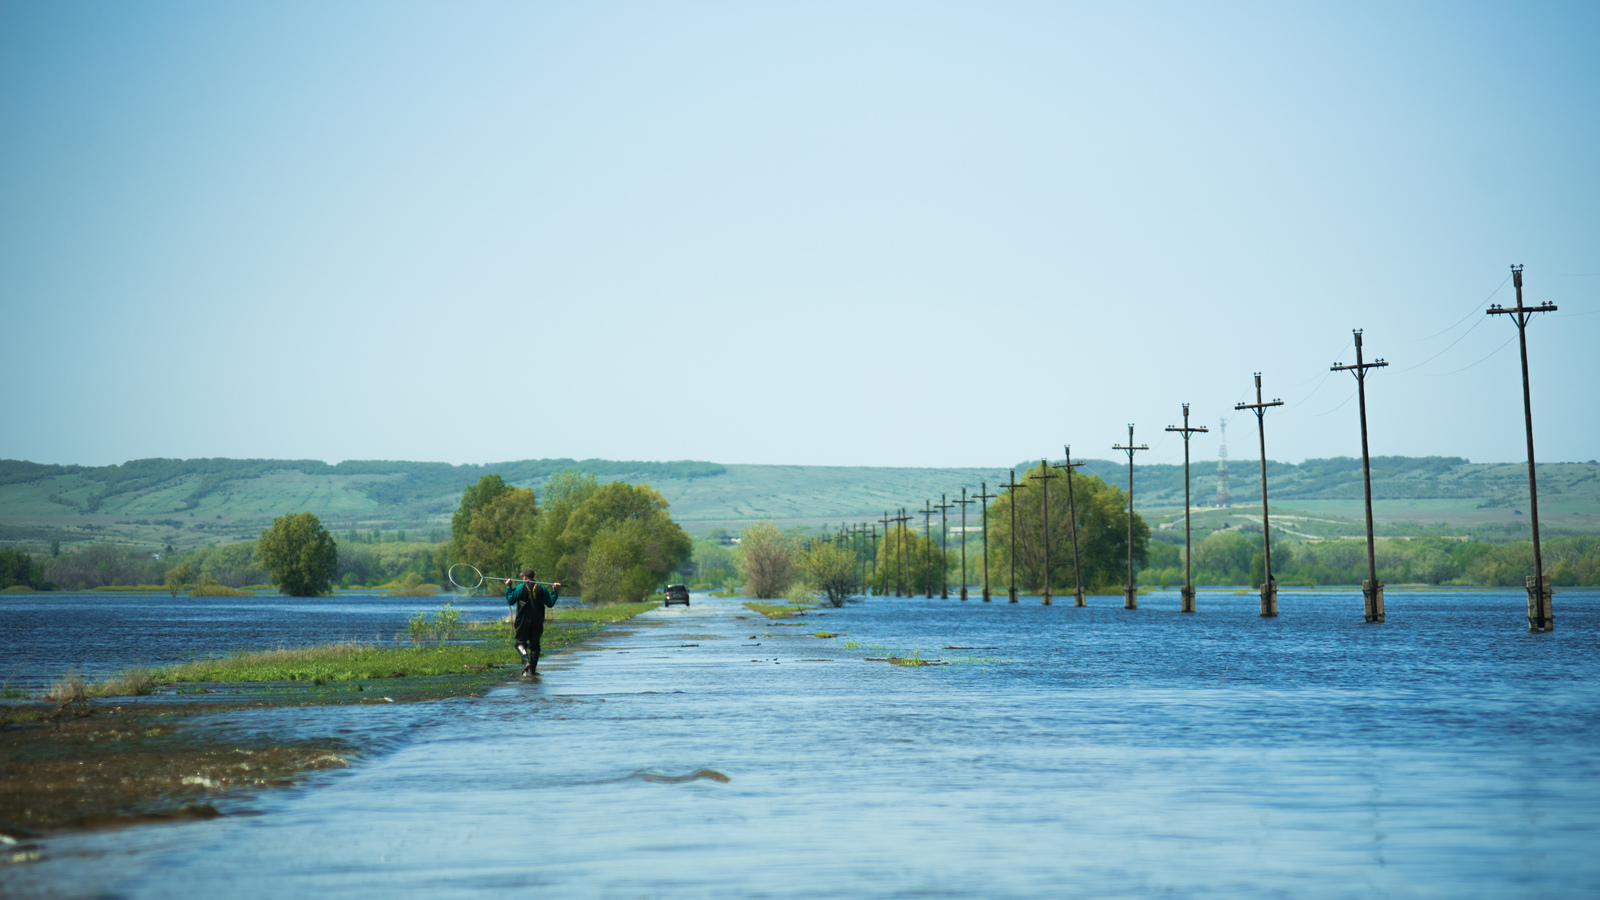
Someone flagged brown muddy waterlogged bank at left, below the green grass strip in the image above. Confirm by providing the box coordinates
[0,666,515,852]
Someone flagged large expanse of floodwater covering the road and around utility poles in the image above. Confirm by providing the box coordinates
[0,591,1600,900]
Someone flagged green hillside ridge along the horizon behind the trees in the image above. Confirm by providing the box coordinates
[0,456,1600,551]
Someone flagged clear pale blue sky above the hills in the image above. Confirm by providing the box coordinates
[0,2,1600,466]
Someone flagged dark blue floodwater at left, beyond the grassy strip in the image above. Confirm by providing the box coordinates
[0,591,518,692]
